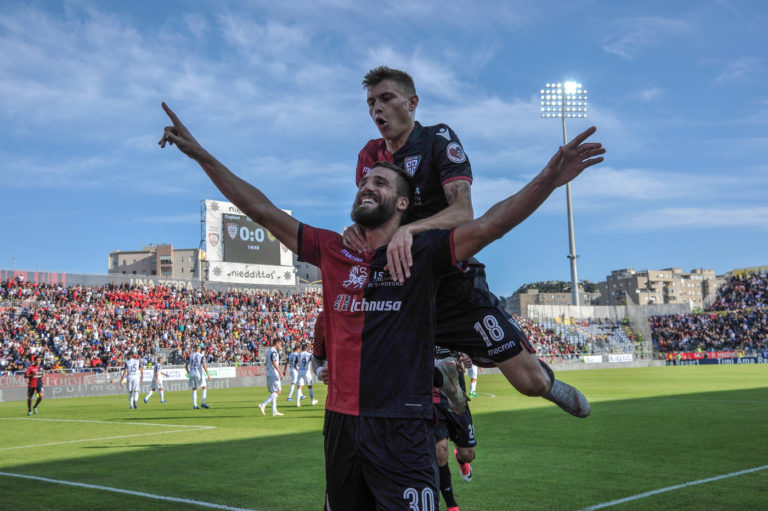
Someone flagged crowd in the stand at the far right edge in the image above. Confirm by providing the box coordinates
[649,273,768,353]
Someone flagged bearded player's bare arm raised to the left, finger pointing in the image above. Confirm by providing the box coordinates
[158,103,299,253]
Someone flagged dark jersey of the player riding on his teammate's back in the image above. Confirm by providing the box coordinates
[355,122,472,222]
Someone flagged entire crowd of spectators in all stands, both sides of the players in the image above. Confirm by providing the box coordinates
[0,273,768,372]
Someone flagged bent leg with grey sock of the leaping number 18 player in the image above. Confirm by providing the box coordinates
[497,351,591,418]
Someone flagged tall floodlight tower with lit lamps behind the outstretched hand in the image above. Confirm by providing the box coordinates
[541,82,587,306]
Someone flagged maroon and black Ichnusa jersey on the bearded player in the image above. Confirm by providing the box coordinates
[297,224,456,419]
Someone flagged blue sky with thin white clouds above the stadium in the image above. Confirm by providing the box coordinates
[0,0,768,295]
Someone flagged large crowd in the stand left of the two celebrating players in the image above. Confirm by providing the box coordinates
[0,279,322,372]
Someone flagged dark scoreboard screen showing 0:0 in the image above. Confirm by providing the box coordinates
[221,213,280,265]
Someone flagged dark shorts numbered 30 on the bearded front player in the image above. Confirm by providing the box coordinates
[323,410,439,511]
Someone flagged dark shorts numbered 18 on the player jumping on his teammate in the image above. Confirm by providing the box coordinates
[435,258,536,367]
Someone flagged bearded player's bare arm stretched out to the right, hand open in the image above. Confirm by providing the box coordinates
[453,126,605,261]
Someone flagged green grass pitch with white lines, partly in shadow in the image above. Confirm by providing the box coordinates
[0,365,768,511]
